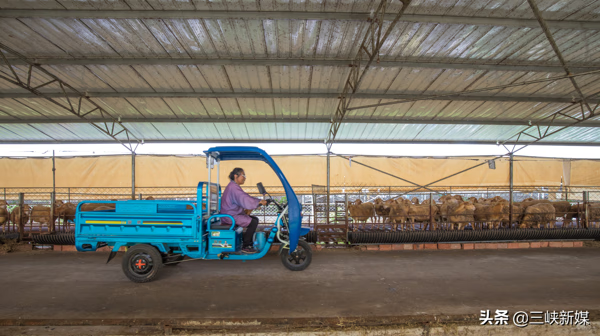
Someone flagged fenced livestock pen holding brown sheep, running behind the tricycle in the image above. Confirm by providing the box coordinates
[1,185,600,246]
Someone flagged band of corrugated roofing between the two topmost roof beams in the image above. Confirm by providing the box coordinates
[0,18,600,63]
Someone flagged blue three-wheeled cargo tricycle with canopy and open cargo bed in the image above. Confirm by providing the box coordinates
[75,146,312,282]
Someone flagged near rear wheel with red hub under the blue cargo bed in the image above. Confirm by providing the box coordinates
[121,244,163,283]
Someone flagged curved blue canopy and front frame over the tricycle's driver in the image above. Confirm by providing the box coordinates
[204,146,302,251]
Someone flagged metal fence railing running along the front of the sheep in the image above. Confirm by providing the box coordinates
[0,186,600,240]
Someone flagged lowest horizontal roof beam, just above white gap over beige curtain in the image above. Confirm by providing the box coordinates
[2,139,600,147]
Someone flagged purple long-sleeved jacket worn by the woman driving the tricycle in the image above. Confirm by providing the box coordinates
[221,181,260,227]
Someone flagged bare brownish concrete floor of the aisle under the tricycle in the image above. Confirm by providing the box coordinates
[0,248,600,319]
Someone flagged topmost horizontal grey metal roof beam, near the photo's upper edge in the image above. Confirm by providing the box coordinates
[0,9,600,30]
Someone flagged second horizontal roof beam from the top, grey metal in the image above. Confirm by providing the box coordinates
[9,57,600,73]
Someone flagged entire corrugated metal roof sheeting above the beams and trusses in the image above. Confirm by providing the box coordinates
[0,0,600,146]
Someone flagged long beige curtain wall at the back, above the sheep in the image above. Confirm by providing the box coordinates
[0,155,600,188]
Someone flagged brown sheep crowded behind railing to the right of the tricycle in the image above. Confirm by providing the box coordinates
[348,195,600,231]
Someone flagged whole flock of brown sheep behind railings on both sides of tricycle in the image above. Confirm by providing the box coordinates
[0,195,600,231]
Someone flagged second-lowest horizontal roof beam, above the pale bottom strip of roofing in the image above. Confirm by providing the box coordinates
[0,118,600,127]
